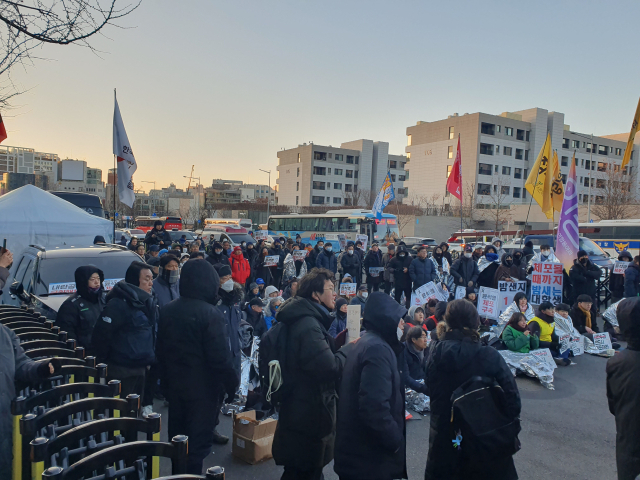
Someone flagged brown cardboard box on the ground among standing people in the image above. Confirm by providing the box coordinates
[231,410,278,465]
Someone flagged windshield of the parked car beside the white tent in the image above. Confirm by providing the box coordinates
[34,251,139,295]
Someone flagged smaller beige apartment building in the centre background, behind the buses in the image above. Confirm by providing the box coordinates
[276,140,407,207]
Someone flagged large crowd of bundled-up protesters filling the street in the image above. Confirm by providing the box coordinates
[0,221,640,480]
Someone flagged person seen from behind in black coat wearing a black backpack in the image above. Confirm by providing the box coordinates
[424,299,521,480]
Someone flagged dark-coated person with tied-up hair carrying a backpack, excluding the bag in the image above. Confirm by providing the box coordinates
[425,300,521,480]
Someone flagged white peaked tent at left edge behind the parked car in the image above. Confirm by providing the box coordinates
[0,185,113,255]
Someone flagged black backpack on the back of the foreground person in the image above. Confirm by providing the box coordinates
[451,376,520,463]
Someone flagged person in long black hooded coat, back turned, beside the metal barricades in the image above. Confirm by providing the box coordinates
[157,261,240,475]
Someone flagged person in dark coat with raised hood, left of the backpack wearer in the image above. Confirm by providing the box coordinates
[333,292,407,480]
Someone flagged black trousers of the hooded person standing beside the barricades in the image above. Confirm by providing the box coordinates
[167,395,219,475]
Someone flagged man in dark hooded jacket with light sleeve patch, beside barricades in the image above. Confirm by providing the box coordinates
[91,262,158,403]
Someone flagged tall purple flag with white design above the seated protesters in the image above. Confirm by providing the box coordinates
[555,156,579,273]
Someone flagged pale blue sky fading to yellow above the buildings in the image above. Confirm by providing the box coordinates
[2,0,640,191]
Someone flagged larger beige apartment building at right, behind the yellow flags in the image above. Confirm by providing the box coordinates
[404,108,638,211]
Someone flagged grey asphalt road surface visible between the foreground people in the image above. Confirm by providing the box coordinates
[156,344,616,480]
